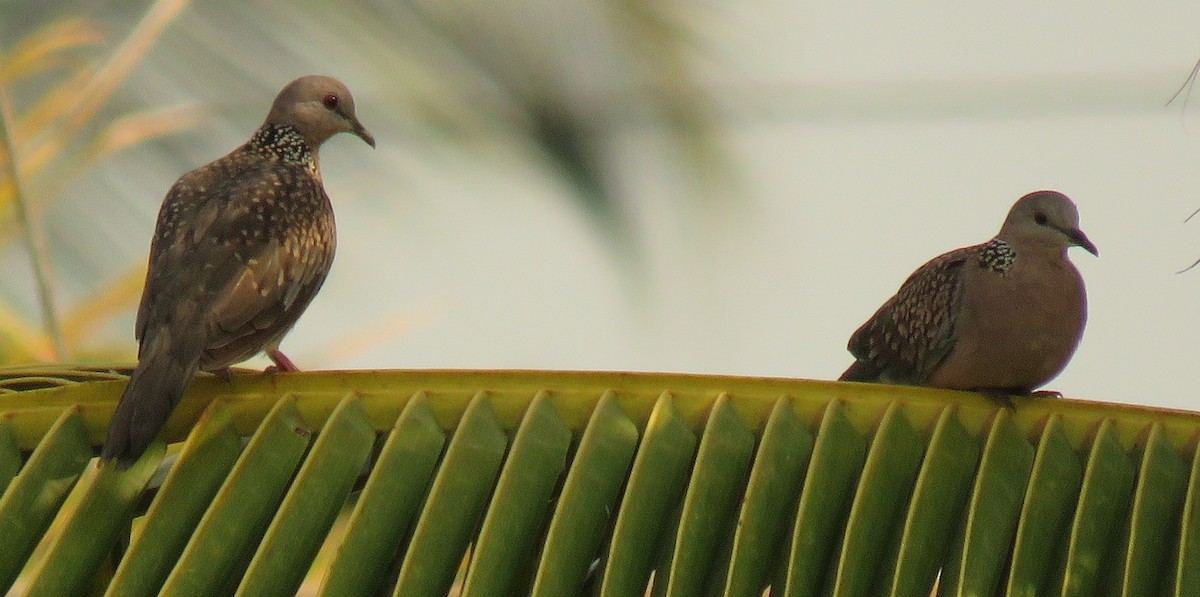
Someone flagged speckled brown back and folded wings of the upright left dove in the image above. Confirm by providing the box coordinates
[137,155,332,367]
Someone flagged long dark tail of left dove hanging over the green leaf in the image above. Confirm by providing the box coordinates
[100,330,199,468]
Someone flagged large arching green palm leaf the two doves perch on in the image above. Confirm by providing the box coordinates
[0,368,1200,596]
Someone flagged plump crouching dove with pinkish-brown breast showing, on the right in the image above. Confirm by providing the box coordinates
[840,191,1099,404]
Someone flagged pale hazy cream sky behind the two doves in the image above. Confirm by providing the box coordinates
[7,0,1200,409]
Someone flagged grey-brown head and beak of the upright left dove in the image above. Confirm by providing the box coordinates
[265,74,374,150]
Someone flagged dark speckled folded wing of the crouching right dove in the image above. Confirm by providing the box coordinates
[847,247,978,384]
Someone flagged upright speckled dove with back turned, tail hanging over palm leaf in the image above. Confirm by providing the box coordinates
[101,76,374,465]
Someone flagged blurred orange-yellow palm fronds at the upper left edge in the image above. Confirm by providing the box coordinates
[0,0,200,361]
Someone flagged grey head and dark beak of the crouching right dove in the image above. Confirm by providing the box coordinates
[996,191,1099,255]
